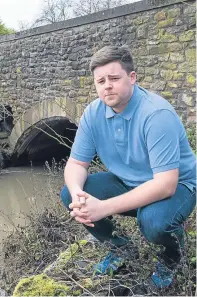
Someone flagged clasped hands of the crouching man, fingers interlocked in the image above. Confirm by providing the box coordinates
[69,191,106,227]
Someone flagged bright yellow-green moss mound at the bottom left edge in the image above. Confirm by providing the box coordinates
[13,273,69,296]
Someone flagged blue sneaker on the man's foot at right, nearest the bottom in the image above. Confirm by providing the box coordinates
[151,262,173,289]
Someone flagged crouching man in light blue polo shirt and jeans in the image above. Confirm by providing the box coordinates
[61,46,196,288]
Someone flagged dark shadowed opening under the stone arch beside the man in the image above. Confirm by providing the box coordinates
[12,116,77,166]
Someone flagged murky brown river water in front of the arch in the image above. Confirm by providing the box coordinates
[0,167,63,241]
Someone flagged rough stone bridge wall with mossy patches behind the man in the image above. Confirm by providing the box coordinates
[0,0,196,123]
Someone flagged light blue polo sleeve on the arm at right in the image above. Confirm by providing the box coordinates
[144,109,180,174]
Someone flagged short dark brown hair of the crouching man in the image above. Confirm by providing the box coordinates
[90,46,134,74]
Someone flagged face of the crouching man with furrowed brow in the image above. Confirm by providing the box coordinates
[94,62,136,113]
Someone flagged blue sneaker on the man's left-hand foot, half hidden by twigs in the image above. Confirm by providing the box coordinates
[94,252,124,275]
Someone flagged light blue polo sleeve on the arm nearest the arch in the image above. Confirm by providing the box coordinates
[70,108,96,162]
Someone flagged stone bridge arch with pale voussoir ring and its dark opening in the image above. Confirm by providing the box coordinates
[9,99,84,165]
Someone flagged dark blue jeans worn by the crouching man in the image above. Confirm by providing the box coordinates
[61,172,196,260]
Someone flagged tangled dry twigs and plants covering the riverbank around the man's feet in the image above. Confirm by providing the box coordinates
[0,126,196,296]
